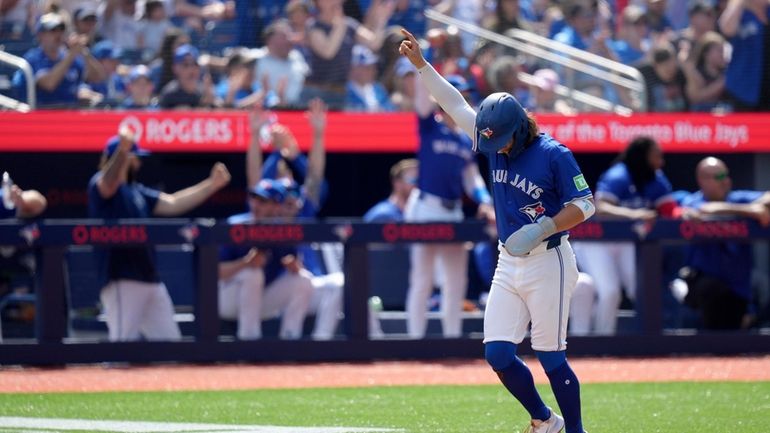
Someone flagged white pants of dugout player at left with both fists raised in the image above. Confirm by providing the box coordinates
[100,280,182,341]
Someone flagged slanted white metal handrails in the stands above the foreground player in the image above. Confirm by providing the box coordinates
[425,9,646,115]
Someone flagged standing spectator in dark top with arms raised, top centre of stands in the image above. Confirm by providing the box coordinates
[301,0,395,109]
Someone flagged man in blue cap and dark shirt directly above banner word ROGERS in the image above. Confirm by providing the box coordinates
[160,45,215,109]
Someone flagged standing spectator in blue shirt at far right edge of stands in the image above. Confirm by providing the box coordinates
[719,0,770,111]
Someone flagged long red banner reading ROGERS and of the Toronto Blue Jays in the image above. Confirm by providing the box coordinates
[0,111,770,153]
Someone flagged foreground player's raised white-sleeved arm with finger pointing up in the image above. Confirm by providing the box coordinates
[398,29,476,138]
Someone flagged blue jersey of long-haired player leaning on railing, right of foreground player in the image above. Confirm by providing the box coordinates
[596,162,673,209]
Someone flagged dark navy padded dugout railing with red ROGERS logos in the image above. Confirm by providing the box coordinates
[0,219,770,364]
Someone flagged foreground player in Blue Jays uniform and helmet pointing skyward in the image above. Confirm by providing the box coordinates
[399,30,595,433]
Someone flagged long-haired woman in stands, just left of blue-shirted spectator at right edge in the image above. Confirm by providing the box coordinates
[682,32,727,112]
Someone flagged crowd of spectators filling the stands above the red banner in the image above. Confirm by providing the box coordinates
[0,0,770,114]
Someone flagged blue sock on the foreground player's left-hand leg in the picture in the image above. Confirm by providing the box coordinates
[484,341,548,418]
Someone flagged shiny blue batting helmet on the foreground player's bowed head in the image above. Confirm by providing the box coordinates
[476,92,529,156]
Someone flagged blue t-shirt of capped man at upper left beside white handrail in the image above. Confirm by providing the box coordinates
[13,47,86,107]
